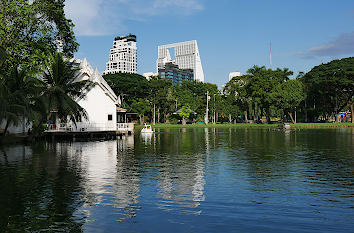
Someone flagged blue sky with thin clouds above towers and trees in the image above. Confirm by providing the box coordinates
[65,0,354,87]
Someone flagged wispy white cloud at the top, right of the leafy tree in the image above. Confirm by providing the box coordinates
[65,0,203,36]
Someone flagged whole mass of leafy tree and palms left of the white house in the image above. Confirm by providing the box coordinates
[0,0,91,137]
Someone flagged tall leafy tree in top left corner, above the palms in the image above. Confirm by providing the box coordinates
[0,0,78,72]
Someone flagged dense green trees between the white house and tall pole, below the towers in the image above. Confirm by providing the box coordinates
[104,73,221,123]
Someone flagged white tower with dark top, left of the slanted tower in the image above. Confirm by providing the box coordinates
[103,34,137,74]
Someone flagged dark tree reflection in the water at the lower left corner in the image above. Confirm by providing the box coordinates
[0,144,84,232]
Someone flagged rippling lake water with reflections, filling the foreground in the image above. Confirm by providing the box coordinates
[0,128,354,233]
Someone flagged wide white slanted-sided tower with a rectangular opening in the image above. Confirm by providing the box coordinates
[156,40,204,82]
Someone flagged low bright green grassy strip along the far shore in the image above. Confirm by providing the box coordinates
[135,123,354,129]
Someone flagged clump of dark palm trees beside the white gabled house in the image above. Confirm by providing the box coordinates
[0,53,93,133]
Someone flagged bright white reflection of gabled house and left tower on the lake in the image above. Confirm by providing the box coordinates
[57,136,139,222]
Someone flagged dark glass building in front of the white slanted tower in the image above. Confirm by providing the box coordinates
[159,62,194,84]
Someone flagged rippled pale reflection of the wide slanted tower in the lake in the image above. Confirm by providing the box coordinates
[156,129,209,214]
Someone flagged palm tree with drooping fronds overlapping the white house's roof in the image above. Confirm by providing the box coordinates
[35,53,93,133]
